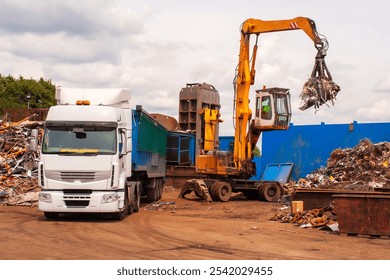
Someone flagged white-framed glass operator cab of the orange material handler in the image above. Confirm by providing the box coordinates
[253,88,291,130]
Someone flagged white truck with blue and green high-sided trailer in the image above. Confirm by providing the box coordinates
[38,87,167,220]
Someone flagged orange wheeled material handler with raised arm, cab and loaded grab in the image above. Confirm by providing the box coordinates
[180,17,340,201]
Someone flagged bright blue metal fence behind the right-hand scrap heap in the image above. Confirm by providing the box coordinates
[220,121,390,180]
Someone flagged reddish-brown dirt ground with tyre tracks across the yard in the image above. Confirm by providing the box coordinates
[0,188,390,260]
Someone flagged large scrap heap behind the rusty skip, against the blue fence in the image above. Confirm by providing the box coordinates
[288,139,390,191]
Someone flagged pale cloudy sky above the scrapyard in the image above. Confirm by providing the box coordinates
[0,0,390,135]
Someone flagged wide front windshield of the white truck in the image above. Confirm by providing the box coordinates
[42,126,116,155]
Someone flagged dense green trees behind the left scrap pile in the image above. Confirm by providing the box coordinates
[0,74,56,114]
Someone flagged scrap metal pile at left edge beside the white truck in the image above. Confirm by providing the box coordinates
[0,115,42,205]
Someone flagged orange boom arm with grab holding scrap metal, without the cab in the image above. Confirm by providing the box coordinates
[233,17,340,174]
